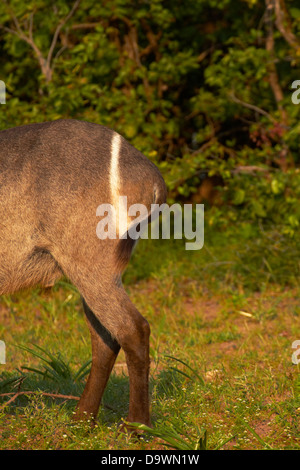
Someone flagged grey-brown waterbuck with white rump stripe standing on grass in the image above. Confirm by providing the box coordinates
[0,119,166,425]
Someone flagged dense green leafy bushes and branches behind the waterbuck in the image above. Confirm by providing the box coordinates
[0,0,300,237]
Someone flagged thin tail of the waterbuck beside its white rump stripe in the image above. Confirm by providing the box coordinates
[116,177,167,272]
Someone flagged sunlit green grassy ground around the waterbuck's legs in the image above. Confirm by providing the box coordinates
[0,222,300,450]
